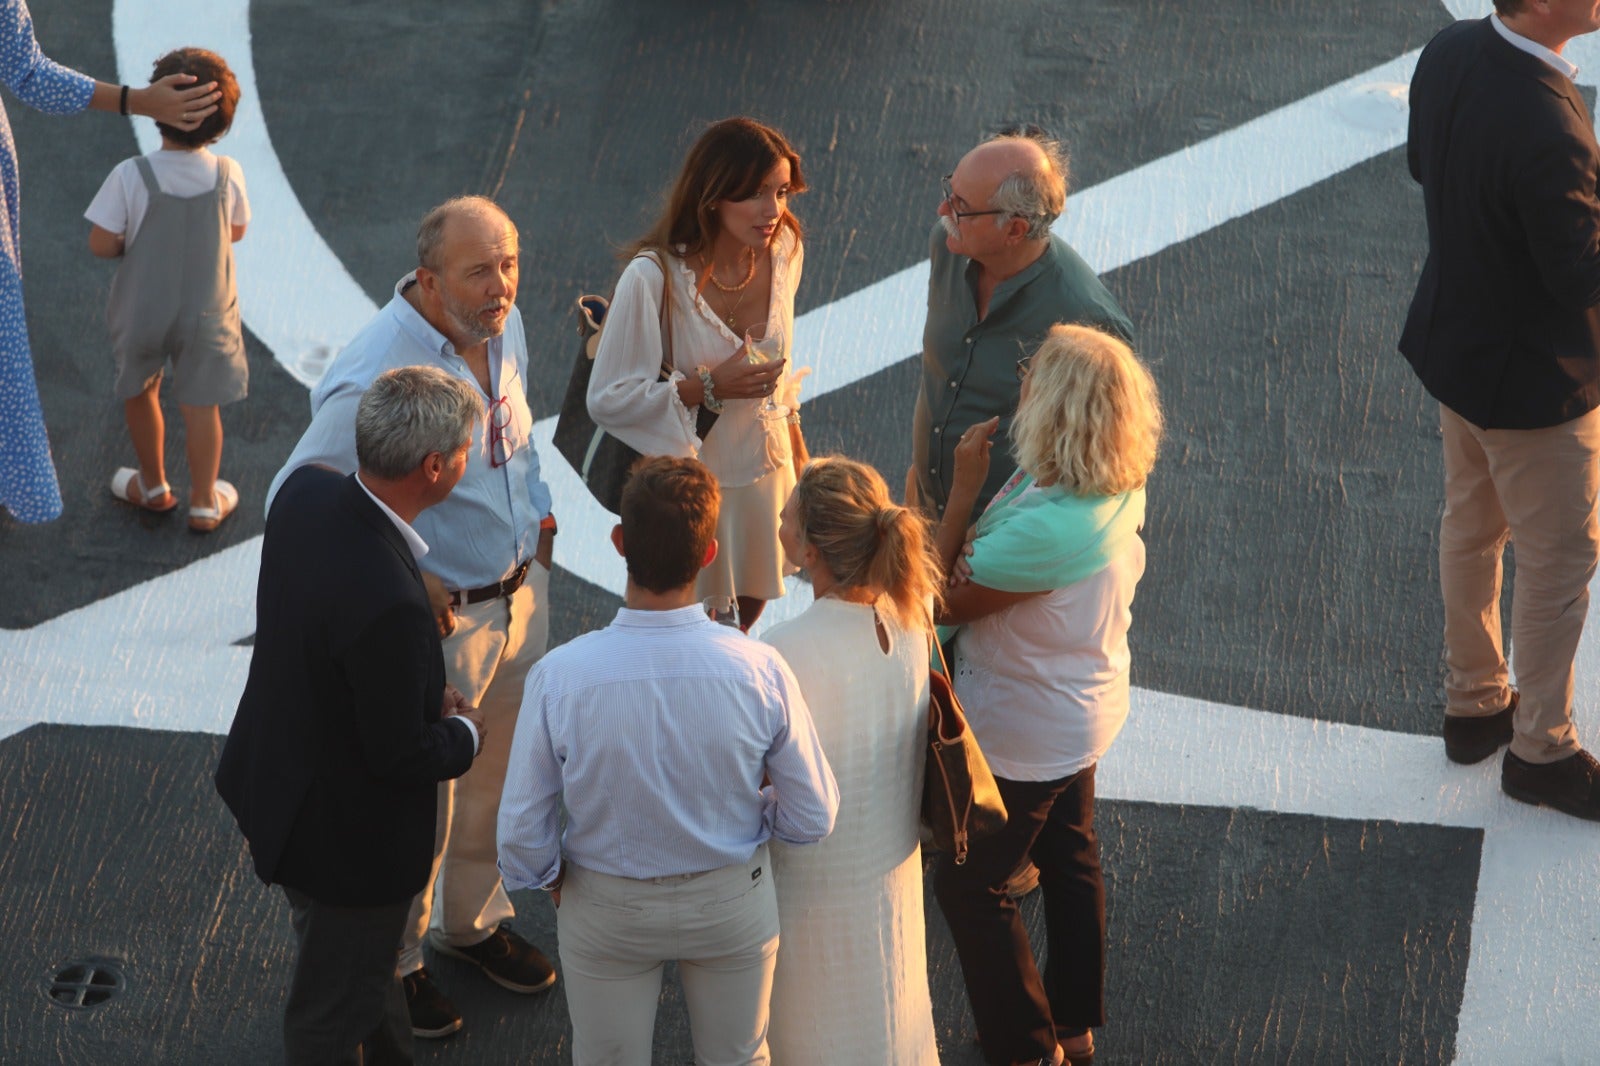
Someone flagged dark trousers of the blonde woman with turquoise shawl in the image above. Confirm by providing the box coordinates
[933,767,1106,1066]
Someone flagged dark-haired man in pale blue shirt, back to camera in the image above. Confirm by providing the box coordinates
[499,456,838,1066]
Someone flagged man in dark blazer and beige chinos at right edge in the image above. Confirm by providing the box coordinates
[1400,0,1600,820]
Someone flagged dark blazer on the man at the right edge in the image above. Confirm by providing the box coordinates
[1400,16,1600,429]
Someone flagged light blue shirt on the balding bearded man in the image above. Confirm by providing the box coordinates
[267,272,550,589]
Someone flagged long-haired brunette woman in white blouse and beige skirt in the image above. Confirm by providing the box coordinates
[589,117,806,629]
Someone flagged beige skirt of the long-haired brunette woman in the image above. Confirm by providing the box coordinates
[694,463,797,600]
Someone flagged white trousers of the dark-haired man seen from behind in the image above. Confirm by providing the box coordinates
[555,845,778,1066]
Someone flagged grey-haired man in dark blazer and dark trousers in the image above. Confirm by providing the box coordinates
[216,367,483,1064]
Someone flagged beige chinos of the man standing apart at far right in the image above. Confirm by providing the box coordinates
[1438,405,1600,763]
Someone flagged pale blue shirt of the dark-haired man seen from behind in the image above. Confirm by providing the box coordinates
[499,607,838,888]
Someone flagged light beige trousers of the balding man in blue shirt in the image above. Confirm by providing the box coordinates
[397,563,550,976]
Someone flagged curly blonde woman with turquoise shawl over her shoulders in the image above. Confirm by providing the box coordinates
[934,325,1162,1066]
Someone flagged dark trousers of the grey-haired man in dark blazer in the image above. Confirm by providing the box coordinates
[283,887,411,1066]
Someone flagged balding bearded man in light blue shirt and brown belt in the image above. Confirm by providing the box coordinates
[267,197,555,1037]
